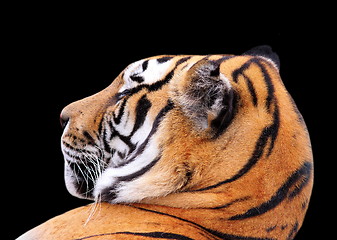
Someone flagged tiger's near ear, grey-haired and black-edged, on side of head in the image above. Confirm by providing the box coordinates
[175,59,236,137]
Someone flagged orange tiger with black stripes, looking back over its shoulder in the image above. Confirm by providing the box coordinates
[19,46,313,240]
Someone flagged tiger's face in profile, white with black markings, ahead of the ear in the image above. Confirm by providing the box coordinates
[61,56,201,202]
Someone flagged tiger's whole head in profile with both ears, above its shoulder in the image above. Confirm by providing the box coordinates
[61,47,313,219]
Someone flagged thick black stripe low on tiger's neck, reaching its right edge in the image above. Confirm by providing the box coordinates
[229,162,312,220]
